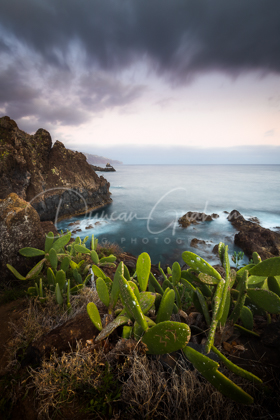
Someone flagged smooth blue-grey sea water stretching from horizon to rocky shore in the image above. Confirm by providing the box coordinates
[57,165,280,265]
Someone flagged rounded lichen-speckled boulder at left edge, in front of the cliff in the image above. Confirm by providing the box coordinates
[0,193,58,282]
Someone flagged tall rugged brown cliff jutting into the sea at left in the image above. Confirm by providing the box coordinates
[0,117,112,220]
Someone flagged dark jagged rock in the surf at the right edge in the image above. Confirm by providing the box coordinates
[228,210,280,259]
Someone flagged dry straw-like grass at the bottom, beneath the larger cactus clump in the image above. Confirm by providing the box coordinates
[122,355,280,420]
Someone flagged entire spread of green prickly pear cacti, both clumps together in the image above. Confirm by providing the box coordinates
[7,232,280,404]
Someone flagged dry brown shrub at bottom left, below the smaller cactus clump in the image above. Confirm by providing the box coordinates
[28,343,120,419]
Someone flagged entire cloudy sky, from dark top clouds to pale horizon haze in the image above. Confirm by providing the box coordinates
[0,0,280,163]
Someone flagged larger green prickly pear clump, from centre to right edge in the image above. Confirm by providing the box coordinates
[88,243,280,404]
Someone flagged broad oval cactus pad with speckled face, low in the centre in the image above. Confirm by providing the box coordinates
[142,321,191,354]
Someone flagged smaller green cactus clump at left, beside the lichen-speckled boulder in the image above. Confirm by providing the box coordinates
[7,232,116,311]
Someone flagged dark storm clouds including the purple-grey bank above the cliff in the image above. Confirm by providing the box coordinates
[0,0,280,130]
